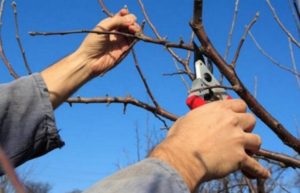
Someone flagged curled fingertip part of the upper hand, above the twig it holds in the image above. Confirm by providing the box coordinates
[97,9,136,31]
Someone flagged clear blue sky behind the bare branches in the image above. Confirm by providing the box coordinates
[0,0,300,193]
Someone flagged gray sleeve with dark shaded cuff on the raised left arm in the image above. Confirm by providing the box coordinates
[0,74,64,174]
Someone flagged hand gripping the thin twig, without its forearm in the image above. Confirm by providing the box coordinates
[76,9,141,76]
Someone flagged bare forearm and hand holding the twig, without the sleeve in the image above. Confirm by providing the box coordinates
[41,9,140,108]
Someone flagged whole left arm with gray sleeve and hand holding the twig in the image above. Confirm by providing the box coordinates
[0,9,140,175]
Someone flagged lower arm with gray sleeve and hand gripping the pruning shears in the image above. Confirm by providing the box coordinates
[85,100,270,193]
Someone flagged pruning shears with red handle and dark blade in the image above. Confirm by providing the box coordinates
[186,42,231,109]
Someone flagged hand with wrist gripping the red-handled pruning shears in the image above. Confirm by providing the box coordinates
[150,100,270,191]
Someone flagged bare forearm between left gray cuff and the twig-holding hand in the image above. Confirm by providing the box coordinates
[41,52,92,109]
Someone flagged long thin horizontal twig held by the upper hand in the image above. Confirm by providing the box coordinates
[29,29,194,50]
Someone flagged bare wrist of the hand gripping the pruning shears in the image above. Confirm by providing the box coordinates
[149,137,206,192]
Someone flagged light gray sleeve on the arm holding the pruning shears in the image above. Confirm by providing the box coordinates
[84,159,190,193]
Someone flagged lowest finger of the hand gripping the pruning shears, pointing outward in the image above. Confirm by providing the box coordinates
[241,155,271,179]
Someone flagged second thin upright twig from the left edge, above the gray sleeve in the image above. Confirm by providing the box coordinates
[11,1,32,74]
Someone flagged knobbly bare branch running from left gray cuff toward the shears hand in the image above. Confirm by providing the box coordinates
[66,96,178,121]
